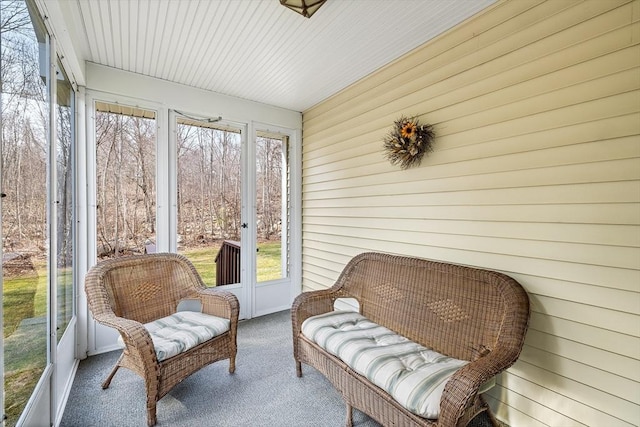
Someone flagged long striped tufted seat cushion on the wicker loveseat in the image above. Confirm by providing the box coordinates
[302,311,468,419]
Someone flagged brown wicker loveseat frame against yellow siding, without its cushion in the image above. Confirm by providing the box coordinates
[291,253,529,427]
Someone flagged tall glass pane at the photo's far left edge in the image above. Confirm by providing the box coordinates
[0,0,49,426]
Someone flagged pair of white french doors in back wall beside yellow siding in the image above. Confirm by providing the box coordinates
[169,111,293,318]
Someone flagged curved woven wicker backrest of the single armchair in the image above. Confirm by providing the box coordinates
[85,253,205,323]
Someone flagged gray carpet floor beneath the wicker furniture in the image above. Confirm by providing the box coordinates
[60,311,498,427]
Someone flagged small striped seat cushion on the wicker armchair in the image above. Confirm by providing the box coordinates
[119,311,230,361]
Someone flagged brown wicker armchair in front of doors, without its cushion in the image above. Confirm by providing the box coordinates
[85,253,239,426]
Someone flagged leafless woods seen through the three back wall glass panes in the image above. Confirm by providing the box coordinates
[96,111,283,257]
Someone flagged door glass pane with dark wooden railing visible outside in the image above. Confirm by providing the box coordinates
[176,117,242,286]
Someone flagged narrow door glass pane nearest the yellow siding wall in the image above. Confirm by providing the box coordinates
[256,132,288,282]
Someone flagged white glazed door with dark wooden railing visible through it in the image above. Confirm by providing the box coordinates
[168,110,251,318]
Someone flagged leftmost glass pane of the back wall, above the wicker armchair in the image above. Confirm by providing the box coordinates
[95,102,156,259]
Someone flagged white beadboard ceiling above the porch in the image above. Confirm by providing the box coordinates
[60,0,495,111]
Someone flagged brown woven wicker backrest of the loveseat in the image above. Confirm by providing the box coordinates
[333,253,529,361]
